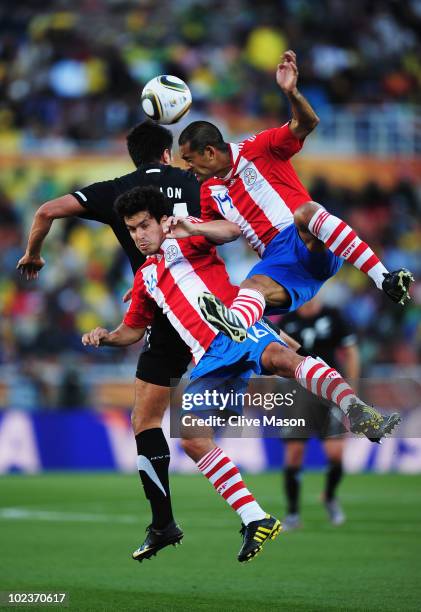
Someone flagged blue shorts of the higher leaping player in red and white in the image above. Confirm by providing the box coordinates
[247,223,343,313]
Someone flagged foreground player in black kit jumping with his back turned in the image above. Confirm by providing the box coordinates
[17,120,200,561]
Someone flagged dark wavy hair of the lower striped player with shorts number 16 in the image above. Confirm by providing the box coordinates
[114,186,172,223]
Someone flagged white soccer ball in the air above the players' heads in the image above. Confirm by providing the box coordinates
[141,74,192,125]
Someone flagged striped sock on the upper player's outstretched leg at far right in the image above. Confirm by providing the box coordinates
[308,208,387,289]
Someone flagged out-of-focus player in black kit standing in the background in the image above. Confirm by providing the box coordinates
[282,297,359,531]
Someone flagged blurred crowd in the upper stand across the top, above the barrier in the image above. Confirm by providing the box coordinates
[0,0,421,150]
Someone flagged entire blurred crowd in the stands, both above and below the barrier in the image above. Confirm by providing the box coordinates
[0,0,421,407]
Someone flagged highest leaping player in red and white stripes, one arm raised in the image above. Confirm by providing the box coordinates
[179,51,413,341]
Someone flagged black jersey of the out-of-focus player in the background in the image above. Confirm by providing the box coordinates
[281,307,356,368]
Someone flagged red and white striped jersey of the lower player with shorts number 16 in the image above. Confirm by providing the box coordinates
[124,217,238,363]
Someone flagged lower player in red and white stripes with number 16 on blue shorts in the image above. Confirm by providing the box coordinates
[82,187,399,561]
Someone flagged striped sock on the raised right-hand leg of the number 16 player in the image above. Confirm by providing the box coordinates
[295,357,358,414]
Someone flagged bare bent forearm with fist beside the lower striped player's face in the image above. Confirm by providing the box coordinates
[163,217,241,244]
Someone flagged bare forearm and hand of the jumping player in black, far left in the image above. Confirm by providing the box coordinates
[16,194,85,280]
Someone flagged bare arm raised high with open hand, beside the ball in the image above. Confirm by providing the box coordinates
[276,50,320,140]
